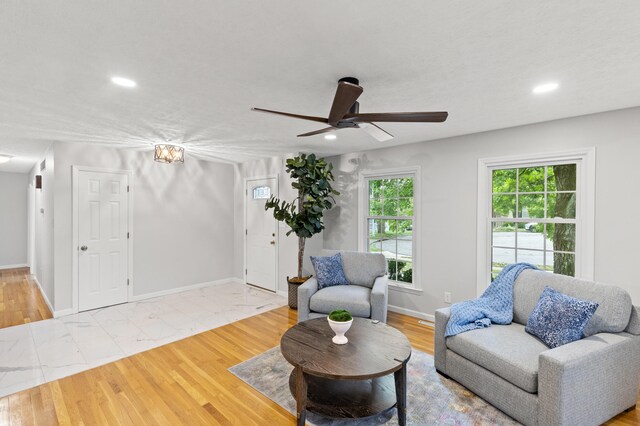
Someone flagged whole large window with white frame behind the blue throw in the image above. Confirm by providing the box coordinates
[477,148,595,294]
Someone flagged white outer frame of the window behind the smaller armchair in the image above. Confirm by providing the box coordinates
[358,166,422,294]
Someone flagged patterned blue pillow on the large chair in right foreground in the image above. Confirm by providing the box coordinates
[525,287,598,348]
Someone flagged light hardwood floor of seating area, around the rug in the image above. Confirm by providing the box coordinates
[0,307,640,425]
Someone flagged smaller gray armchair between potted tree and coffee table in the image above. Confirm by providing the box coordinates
[298,250,389,322]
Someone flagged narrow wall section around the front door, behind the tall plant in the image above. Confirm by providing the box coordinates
[234,154,323,292]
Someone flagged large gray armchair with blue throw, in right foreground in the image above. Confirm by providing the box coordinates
[435,270,640,426]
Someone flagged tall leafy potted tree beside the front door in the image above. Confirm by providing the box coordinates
[265,154,340,309]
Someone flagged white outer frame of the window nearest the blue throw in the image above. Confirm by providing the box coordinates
[476,147,596,296]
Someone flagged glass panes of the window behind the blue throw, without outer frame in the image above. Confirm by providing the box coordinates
[491,163,577,279]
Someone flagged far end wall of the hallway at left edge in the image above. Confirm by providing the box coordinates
[0,172,29,268]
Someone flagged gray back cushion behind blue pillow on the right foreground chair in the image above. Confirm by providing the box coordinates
[513,270,632,336]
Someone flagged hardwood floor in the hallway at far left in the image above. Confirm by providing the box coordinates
[0,268,52,328]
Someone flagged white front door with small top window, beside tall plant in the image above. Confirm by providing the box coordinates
[245,178,278,292]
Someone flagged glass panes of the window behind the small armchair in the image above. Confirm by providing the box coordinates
[362,169,417,288]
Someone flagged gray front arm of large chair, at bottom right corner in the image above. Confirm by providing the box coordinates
[538,333,640,425]
